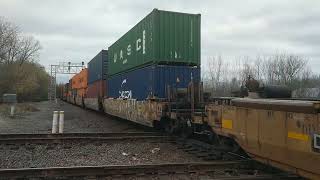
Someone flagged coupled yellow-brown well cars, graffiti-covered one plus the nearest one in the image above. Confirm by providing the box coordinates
[104,83,320,179]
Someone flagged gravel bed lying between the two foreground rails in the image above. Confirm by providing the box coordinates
[0,142,201,168]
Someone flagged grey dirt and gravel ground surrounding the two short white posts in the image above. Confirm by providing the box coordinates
[0,101,147,134]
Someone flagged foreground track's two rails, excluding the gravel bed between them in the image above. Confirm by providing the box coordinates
[0,132,298,180]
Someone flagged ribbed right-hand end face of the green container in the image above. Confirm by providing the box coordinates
[154,11,201,65]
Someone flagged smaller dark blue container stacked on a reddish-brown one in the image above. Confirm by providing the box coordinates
[88,50,108,84]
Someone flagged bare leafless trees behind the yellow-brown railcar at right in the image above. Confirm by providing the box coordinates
[203,53,320,97]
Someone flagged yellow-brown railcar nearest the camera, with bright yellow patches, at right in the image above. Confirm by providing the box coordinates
[202,98,320,179]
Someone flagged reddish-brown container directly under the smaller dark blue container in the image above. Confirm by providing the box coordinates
[86,80,106,98]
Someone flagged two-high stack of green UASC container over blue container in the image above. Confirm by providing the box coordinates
[107,9,201,100]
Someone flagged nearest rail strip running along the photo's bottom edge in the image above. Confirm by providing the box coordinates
[0,161,298,180]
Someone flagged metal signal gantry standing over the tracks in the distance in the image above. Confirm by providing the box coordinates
[48,62,85,101]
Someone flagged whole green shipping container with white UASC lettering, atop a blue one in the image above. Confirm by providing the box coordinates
[108,9,201,76]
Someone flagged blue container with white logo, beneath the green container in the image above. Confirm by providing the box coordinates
[106,65,200,100]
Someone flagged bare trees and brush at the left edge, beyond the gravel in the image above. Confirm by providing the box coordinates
[0,17,49,101]
